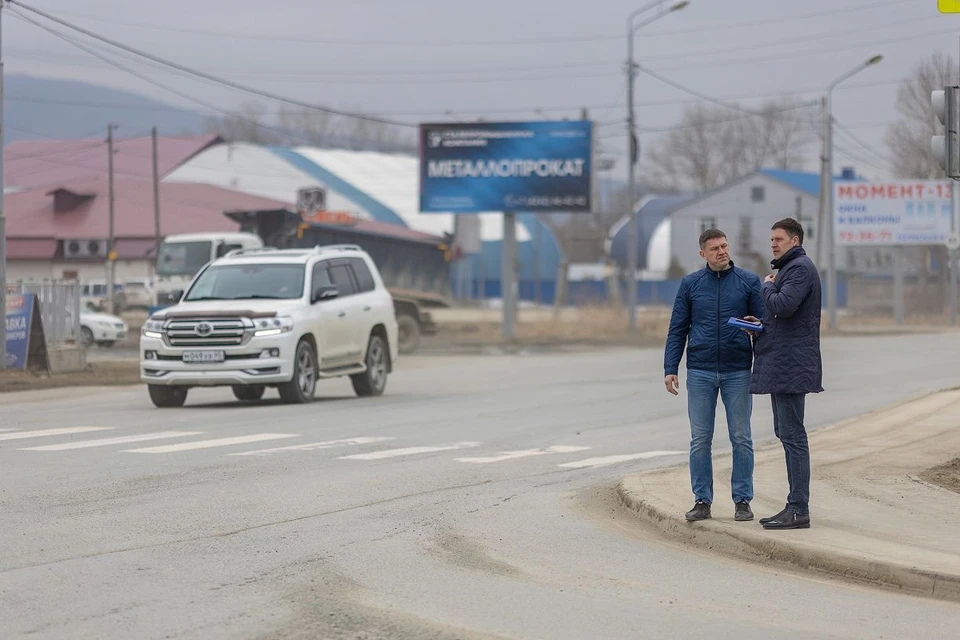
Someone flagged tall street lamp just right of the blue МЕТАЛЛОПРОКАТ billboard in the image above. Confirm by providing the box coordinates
[627,0,690,331]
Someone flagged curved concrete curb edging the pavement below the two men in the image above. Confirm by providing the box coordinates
[617,476,960,603]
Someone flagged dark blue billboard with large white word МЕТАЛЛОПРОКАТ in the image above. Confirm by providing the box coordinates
[420,120,593,213]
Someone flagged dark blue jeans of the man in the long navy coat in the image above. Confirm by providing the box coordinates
[770,393,810,516]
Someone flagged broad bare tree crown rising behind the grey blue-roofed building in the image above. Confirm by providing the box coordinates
[644,100,816,191]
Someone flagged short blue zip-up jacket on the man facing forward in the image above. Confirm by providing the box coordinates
[663,262,763,376]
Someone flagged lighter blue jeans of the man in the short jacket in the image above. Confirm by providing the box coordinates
[687,369,753,504]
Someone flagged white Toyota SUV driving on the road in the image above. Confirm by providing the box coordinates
[140,245,398,407]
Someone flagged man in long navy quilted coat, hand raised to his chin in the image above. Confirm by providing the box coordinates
[750,218,823,529]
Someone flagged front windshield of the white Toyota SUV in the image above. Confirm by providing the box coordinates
[184,264,304,301]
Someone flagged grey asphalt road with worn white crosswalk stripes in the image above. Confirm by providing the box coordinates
[0,334,960,640]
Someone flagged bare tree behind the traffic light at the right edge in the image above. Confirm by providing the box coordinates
[886,51,957,179]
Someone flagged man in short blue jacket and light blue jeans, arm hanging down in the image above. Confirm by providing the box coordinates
[663,229,763,521]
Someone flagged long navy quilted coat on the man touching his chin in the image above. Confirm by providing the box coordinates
[750,247,823,394]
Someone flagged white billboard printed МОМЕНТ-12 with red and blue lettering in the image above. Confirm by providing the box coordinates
[833,180,953,246]
